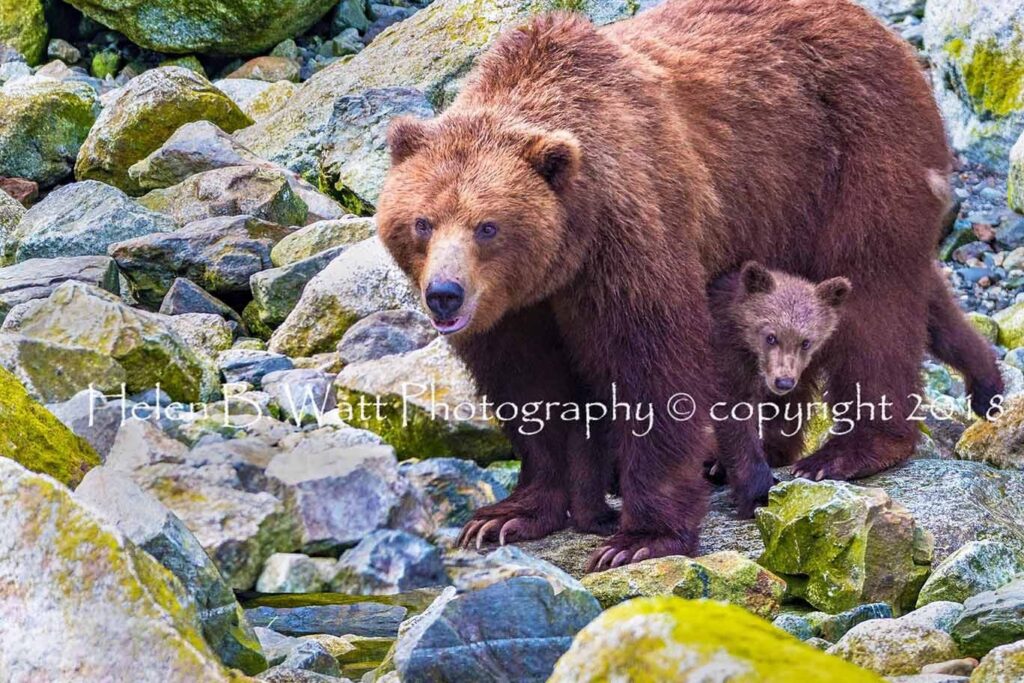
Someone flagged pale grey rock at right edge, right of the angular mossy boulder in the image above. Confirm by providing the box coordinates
[918,541,1024,607]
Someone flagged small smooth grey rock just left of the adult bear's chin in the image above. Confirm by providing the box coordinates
[338,310,437,364]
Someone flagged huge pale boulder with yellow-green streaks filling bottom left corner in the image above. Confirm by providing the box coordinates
[0,459,232,683]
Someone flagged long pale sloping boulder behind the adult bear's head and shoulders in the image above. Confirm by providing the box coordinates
[239,0,643,181]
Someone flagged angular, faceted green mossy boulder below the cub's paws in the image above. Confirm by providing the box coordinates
[757,479,934,613]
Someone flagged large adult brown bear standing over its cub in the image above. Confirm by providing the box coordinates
[378,0,998,567]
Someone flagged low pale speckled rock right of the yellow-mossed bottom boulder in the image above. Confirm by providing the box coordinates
[827,618,957,676]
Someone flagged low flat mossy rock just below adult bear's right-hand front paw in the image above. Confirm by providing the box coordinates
[582,552,785,620]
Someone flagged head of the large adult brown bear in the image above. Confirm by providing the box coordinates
[377,113,581,335]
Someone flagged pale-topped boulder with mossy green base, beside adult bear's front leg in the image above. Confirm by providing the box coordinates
[335,339,512,464]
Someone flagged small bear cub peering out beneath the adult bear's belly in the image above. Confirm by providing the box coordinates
[708,261,852,517]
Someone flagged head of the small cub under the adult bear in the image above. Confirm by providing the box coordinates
[734,262,852,396]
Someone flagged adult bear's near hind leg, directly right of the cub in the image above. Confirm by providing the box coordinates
[793,278,931,480]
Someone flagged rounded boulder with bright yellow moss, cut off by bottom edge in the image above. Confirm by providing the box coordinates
[549,597,882,683]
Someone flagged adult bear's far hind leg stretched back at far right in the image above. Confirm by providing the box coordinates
[928,268,1004,418]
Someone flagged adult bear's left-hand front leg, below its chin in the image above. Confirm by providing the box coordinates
[453,305,577,547]
